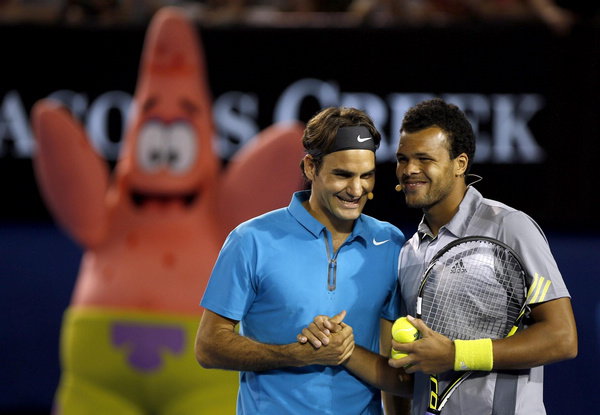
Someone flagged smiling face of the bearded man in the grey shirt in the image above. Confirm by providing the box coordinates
[396,127,468,212]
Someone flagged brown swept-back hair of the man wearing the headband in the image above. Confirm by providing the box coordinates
[300,107,381,180]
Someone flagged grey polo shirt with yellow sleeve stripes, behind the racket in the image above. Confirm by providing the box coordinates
[399,186,570,415]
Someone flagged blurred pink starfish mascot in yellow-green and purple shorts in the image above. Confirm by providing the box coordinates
[32,7,303,415]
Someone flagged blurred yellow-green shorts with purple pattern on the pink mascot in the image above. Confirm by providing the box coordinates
[54,308,239,415]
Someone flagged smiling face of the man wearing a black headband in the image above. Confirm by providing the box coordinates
[304,150,375,232]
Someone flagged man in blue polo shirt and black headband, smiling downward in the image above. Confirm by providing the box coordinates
[196,107,411,415]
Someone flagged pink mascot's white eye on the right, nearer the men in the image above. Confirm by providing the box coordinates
[165,122,198,173]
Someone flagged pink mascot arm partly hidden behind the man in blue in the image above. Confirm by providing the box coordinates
[218,122,304,236]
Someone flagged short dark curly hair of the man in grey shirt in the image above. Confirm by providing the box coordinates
[400,98,476,174]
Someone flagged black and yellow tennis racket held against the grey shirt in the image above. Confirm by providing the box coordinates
[416,236,527,415]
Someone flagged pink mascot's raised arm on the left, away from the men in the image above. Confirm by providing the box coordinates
[32,99,109,247]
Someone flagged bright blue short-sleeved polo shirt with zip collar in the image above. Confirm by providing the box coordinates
[201,191,405,415]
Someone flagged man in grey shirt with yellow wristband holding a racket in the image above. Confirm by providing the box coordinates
[390,98,577,415]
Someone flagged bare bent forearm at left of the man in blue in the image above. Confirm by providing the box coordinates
[195,309,354,371]
